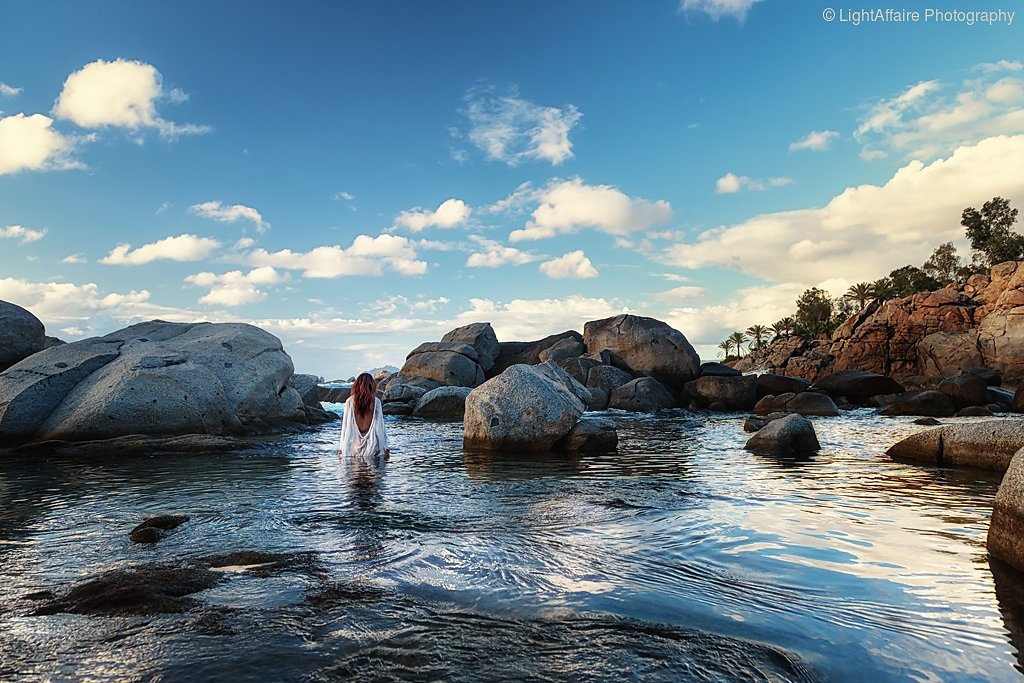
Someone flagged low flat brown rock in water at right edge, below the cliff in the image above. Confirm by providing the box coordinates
[886,419,1024,472]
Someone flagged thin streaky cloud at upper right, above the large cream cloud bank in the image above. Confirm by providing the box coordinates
[854,68,1024,161]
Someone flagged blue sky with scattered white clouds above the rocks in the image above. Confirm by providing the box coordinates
[0,0,1024,379]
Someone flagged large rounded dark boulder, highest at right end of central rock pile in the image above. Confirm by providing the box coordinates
[584,314,700,389]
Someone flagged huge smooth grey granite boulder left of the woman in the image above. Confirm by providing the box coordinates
[0,321,307,445]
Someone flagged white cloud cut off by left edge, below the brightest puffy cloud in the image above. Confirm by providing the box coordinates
[0,114,82,175]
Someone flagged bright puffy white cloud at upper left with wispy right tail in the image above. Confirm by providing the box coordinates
[53,59,210,138]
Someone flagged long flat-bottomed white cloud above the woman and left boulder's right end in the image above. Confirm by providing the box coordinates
[238,234,427,278]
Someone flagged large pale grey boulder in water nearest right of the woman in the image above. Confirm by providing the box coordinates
[463,365,584,453]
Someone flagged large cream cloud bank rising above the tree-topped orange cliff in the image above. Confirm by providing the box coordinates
[665,135,1024,285]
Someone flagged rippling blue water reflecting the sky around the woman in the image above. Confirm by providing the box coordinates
[0,411,1024,682]
